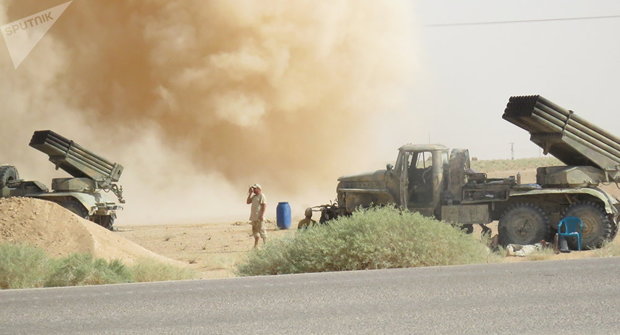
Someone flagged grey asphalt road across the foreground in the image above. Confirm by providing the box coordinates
[0,258,620,335]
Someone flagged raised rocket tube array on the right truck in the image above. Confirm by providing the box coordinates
[502,95,620,172]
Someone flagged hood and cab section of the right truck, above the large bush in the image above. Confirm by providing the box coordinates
[331,144,498,230]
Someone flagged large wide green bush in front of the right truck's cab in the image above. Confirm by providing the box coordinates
[237,207,489,276]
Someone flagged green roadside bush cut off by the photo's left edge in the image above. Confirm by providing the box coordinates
[0,243,51,289]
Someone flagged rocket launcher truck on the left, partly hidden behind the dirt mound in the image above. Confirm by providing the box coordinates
[0,130,125,230]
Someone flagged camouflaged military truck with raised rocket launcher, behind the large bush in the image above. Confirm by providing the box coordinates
[321,95,620,248]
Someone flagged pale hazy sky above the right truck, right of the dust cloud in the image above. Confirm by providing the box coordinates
[397,0,620,159]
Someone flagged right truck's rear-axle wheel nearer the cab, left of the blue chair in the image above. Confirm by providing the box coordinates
[498,203,549,247]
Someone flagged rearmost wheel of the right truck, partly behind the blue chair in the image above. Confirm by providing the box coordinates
[564,201,612,249]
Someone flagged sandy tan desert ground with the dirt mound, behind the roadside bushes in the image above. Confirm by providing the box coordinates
[0,164,620,279]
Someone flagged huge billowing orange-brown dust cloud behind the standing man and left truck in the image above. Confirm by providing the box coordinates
[0,0,415,224]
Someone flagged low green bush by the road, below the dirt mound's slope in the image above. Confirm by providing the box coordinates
[45,254,132,287]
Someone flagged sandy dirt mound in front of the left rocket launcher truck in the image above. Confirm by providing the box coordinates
[0,198,183,265]
